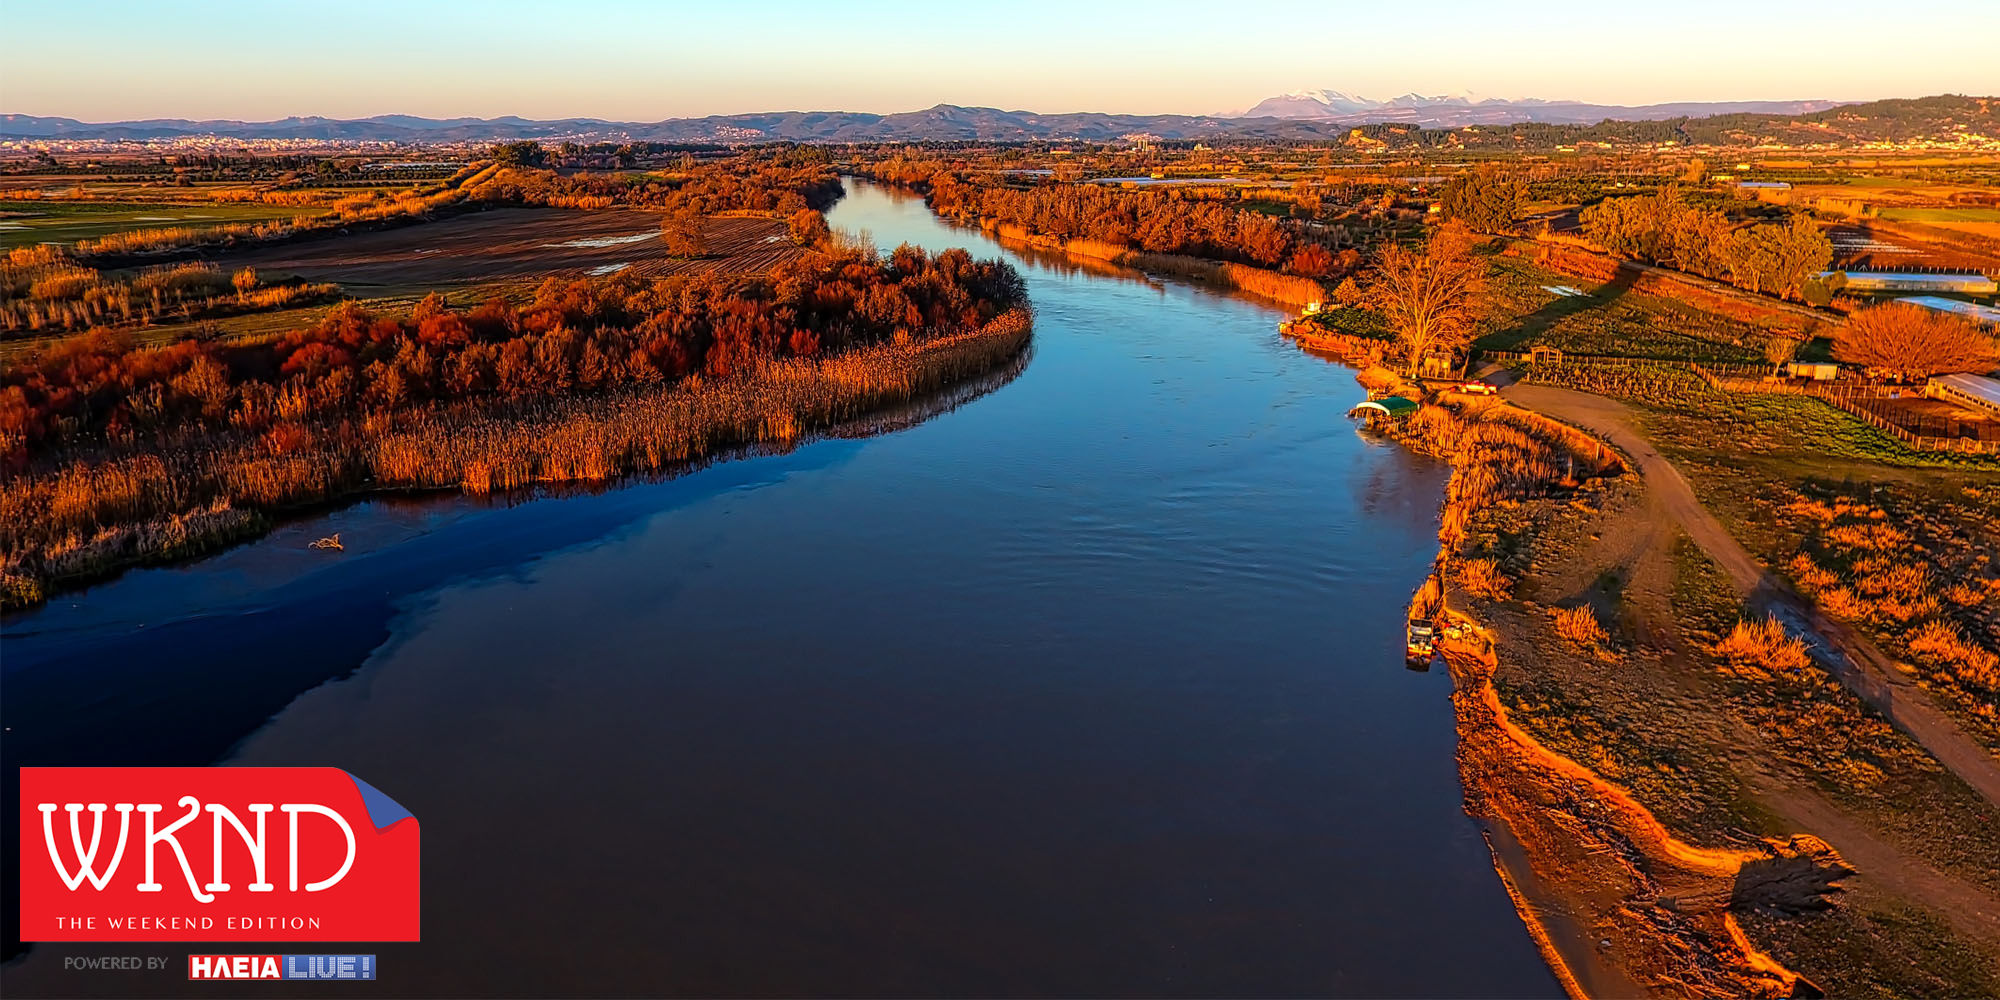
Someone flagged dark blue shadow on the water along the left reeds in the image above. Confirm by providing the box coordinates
[0,346,1034,958]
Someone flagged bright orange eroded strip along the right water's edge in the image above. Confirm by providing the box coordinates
[1358,376,1850,996]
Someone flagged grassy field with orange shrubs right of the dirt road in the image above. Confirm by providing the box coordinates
[1528,364,2000,748]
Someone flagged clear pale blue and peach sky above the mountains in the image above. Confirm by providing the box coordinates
[0,0,2000,122]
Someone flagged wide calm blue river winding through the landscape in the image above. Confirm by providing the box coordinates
[0,182,1560,996]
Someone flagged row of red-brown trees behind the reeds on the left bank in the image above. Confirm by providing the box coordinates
[0,246,1026,470]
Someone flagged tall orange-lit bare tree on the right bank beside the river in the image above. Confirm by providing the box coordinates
[1366,222,1486,376]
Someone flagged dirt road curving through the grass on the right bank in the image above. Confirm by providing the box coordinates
[1502,386,2000,806]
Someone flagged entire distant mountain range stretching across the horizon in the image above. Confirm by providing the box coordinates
[0,90,2000,148]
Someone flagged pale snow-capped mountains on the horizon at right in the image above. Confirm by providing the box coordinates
[1242,90,1842,128]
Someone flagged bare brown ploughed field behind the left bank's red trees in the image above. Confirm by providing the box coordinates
[199,208,802,286]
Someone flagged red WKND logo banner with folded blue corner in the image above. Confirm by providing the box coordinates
[20,768,422,942]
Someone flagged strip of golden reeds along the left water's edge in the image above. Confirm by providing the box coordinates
[0,308,1032,610]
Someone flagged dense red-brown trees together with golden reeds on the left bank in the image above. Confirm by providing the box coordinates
[0,246,1028,604]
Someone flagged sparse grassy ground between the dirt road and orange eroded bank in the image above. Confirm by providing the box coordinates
[1468,452,2000,996]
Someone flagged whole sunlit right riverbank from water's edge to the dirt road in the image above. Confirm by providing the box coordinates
[1360,370,2000,996]
